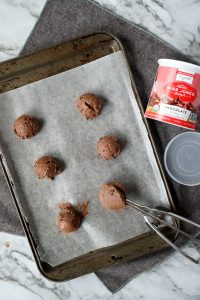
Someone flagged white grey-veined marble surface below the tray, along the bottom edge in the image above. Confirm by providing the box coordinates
[0,233,200,300]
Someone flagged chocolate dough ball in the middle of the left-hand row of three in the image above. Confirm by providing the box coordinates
[34,156,61,179]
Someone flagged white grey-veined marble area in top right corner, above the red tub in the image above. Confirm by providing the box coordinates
[94,0,200,62]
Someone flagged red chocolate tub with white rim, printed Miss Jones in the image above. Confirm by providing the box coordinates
[145,59,200,130]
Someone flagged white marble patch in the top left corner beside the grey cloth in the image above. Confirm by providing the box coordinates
[0,0,46,61]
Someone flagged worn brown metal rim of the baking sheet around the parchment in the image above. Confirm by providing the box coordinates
[0,32,179,281]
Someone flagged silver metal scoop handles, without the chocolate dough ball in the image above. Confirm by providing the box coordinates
[126,199,200,264]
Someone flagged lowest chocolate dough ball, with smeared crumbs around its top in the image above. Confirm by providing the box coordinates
[56,202,82,233]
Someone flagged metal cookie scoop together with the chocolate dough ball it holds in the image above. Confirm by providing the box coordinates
[99,182,200,264]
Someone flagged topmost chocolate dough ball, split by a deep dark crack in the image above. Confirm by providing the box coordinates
[76,94,101,120]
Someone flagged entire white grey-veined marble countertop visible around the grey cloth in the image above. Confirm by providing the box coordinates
[0,0,200,300]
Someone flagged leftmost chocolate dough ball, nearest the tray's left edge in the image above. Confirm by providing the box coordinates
[14,115,39,139]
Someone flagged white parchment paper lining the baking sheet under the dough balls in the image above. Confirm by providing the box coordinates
[0,51,168,266]
